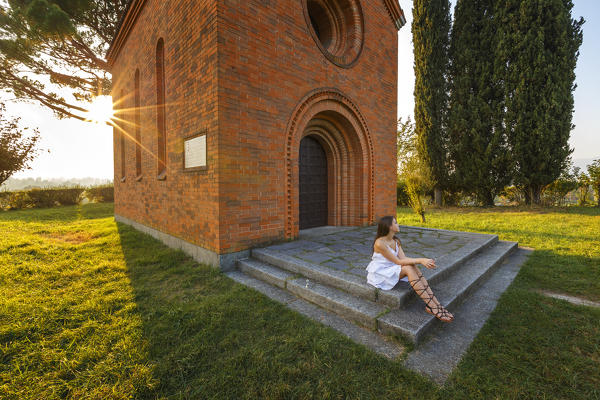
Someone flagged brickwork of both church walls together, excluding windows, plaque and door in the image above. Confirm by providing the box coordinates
[113,0,410,254]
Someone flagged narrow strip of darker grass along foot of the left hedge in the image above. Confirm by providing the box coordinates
[0,203,114,222]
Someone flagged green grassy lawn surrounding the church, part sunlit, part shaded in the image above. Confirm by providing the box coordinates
[0,204,600,399]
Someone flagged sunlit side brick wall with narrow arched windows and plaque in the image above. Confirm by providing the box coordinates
[113,0,219,252]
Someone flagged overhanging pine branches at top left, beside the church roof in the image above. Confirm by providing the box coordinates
[0,0,128,120]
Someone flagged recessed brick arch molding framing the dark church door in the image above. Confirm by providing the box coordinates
[285,88,374,239]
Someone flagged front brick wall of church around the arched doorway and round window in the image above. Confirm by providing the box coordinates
[218,0,397,251]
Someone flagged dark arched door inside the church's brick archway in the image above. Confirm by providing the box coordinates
[299,136,327,229]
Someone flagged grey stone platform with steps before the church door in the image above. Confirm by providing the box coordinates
[227,226,526,383]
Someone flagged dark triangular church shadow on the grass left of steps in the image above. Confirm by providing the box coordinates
[117,223,437,399]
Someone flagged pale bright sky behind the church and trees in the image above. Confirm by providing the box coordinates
[0,0,600,179]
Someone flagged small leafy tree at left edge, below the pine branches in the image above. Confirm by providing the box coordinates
[0,103,39,185]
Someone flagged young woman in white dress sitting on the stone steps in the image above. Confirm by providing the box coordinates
[367,216,454,322]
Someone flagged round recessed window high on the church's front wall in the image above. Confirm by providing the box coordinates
[303,0,364,68]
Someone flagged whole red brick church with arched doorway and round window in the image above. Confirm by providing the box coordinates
[107,0,411,268]
